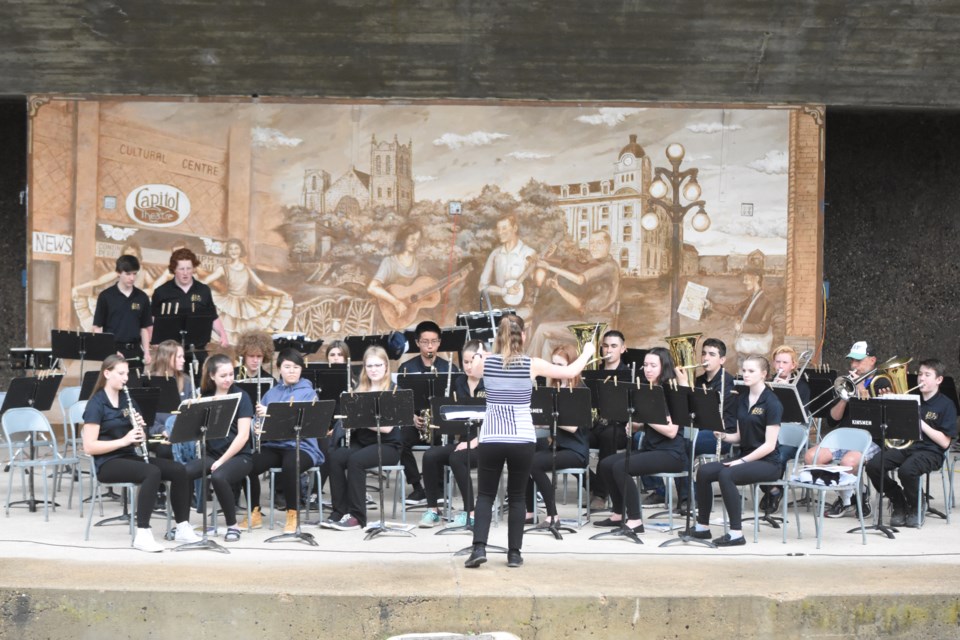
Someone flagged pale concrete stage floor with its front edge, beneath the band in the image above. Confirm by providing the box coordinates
[0,464,960,639]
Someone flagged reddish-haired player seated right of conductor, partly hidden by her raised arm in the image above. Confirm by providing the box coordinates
[527,345,592,525]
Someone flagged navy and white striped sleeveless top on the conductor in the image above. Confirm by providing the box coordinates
[480,355,537,443]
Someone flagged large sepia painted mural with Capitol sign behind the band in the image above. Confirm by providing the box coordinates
[29,98,822,362]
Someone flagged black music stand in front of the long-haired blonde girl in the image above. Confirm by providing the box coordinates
[340,389,415,540]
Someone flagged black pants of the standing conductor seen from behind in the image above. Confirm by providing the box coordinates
[473,442,537,551]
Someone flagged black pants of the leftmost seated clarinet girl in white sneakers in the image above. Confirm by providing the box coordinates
[99,456,190,529]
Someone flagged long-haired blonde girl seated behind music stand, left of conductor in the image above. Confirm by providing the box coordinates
[320,346,402,531]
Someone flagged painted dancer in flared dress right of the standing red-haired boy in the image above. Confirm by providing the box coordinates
[202,238,293,344]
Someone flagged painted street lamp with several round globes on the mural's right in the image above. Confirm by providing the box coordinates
[640,142,710,335]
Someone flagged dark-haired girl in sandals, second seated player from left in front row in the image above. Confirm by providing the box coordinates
[187,353,254,542]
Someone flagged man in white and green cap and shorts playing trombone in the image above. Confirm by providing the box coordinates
[804,340,891,518]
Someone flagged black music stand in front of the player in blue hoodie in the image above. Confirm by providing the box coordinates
[256,400,336,547]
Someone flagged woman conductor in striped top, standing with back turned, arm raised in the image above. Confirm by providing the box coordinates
[464,315,595,568]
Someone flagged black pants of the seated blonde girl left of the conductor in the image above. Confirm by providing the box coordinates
[330,443,402,526]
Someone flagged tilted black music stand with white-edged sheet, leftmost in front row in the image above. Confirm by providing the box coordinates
[170,393,241,553]
